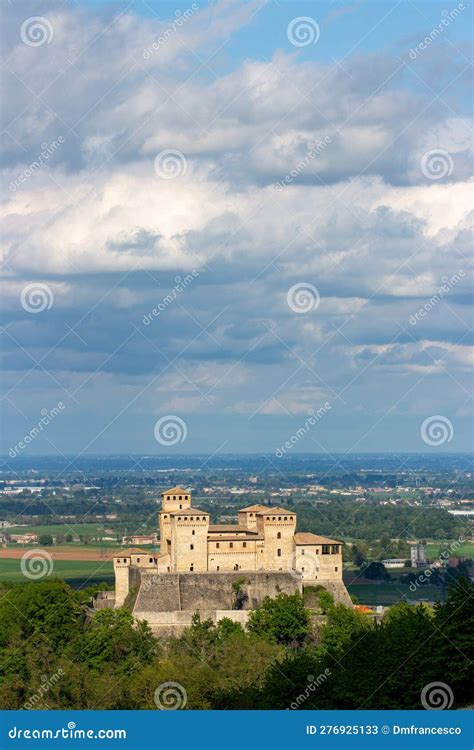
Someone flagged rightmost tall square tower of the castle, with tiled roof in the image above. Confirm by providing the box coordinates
[257,508,296,570]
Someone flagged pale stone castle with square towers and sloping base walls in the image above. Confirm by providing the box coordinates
[114,487,350,627]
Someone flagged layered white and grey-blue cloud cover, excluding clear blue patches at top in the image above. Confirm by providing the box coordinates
[0,0,472,452]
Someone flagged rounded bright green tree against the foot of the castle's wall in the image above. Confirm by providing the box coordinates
[247,593,310,646]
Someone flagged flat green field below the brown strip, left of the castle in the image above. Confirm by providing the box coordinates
[0,558,114,588]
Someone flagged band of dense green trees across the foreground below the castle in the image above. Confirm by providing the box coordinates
[0,578,474,709]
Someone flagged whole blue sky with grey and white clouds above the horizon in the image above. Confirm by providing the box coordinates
[0,0,473,458]
